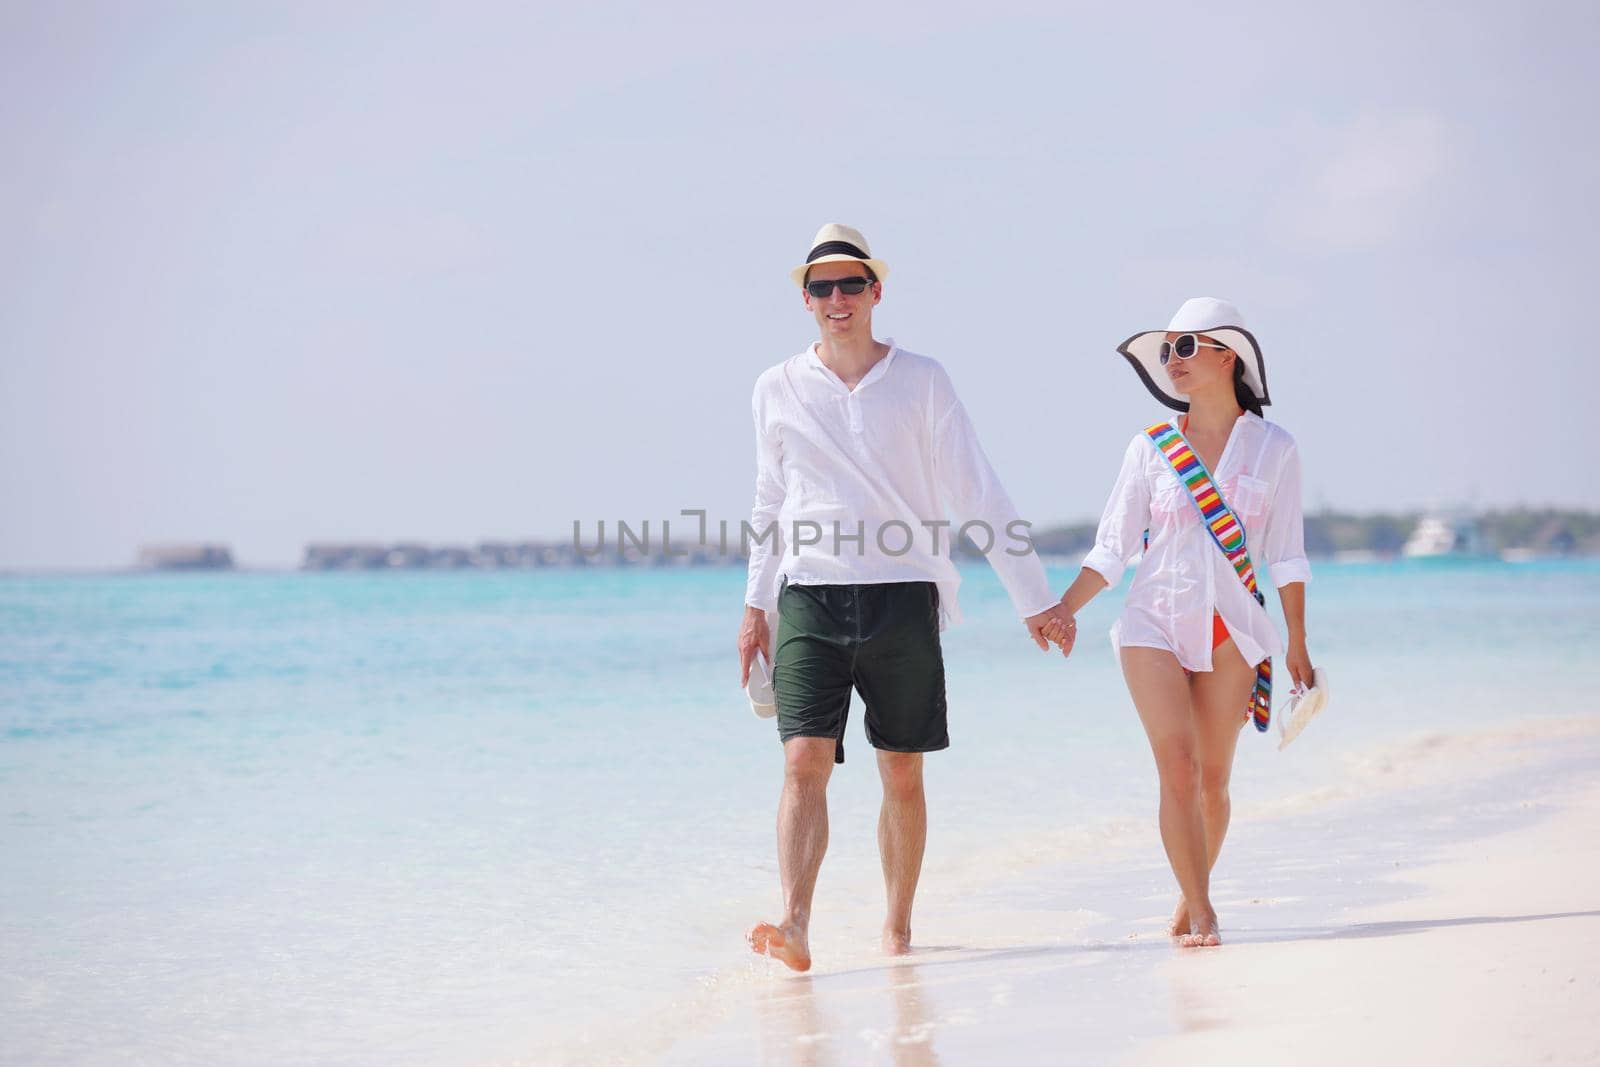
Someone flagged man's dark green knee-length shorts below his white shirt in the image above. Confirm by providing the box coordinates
[773,582,950,763]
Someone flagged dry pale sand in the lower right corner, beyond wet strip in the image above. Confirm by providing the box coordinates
[1133,787,1600,1064]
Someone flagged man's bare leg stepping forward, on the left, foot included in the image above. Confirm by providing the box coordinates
[746,737,835,971]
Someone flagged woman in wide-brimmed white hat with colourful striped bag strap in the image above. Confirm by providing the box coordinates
[1045,298,1312,945]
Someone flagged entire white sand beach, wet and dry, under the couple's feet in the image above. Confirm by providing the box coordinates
[556,718,1600,1065]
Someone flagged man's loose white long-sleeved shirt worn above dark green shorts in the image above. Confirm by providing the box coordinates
[744,341,1056,627]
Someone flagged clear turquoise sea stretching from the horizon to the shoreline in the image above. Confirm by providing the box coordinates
[0,561,1600,1065]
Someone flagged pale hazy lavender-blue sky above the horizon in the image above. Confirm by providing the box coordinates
[0,0,1600,568]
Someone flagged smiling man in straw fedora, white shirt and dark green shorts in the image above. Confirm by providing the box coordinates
[739,224,1075,971]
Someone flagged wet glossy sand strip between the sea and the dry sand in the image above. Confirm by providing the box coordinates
[652,717,1600,1067]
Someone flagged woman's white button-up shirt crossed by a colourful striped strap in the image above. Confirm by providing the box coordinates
[1083,411,1310,670]
